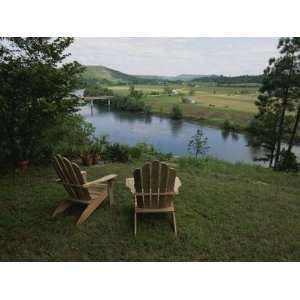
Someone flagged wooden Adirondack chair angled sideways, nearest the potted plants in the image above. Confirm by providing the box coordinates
[53,155,117,224]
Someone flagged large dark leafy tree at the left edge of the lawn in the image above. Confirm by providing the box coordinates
[0,38,82,163]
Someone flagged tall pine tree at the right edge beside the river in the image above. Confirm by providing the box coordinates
[256,38,300,170]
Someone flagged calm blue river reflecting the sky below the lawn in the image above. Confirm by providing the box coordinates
[80,104,300,164]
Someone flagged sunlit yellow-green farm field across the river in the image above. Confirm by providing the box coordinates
[110,84,258,128]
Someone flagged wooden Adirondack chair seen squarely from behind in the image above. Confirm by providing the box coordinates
[126,161,181,235]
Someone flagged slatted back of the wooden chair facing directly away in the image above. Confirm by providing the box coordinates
[133,161,176,209]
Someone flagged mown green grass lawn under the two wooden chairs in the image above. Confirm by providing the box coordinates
[0,160,300,261]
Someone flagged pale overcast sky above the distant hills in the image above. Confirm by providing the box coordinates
[70,38,278,76]
